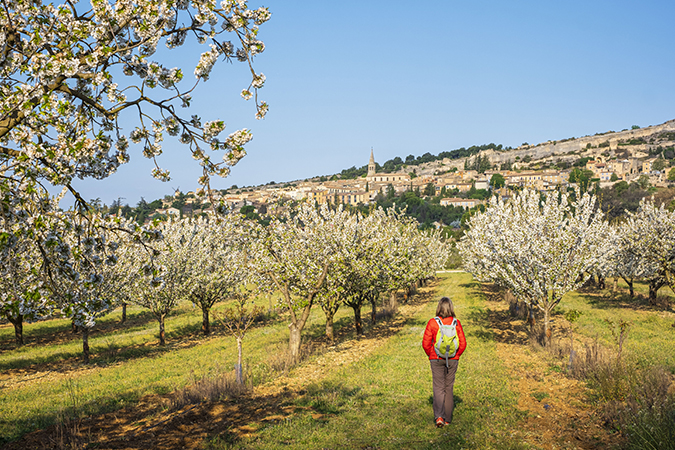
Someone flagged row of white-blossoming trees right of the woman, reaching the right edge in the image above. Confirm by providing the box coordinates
[458,190,675,338]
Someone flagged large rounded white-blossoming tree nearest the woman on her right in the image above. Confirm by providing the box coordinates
[458,189,608,339]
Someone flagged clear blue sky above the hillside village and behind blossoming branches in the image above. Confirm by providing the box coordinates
[67,0,675,206]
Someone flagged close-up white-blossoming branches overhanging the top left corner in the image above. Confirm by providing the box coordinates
[0,0,270,318]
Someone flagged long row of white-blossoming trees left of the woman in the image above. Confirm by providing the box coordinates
[0,204,447,362]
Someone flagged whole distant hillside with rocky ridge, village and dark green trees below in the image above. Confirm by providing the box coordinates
[94,120,675,226]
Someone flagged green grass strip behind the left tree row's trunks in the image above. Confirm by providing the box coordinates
[0,301,360,442]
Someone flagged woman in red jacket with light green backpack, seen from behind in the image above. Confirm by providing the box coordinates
[422,297,466,427]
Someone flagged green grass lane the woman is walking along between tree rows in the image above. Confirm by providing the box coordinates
[209,274,526,449]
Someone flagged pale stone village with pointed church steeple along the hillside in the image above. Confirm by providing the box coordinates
[146,120,675,220]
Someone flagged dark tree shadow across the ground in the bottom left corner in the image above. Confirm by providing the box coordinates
[0,380,326,450]
